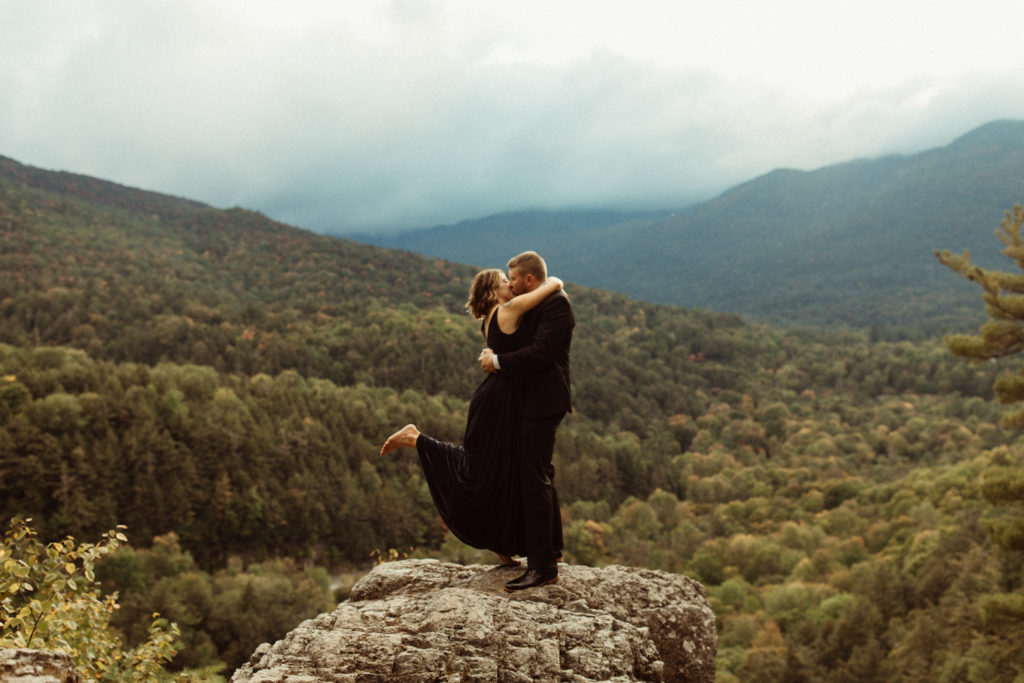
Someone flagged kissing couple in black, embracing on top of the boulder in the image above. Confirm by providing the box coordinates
[381,252,575,591]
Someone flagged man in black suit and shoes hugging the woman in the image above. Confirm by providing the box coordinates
[480,252,575,591]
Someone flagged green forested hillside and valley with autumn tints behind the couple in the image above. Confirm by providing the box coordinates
[0,160,1024,681]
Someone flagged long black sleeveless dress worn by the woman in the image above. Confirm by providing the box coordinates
[416,313,526,556]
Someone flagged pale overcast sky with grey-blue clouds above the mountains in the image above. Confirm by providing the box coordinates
[6,0,1024,232]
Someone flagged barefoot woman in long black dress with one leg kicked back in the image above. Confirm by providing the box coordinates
[381,269,562,564]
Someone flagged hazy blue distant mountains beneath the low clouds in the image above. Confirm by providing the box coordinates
[351,121,1024,334]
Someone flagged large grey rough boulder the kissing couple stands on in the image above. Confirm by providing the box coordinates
[231,560,718,683]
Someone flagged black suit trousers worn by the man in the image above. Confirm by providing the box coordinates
[520,415,564,570]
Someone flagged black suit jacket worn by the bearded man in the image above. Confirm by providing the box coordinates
[498,292,575,418]
